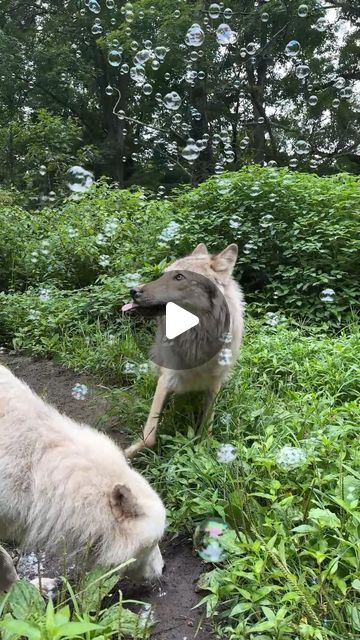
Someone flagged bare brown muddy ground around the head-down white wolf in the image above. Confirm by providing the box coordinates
[0,354,217,640]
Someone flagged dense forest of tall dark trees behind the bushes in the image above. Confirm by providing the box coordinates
[0,0,360,206]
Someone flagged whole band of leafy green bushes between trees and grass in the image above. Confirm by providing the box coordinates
[0,166,360,323]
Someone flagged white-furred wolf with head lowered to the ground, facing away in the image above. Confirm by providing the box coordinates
[0,365,165,580]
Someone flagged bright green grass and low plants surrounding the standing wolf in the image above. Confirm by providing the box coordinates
[2,293,360,640]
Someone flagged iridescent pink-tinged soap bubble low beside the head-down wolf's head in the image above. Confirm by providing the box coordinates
[194,518,229,563]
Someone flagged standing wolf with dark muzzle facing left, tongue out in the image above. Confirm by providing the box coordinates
[123,243,245,458]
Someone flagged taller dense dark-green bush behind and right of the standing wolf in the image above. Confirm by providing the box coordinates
[169,166,360,319]
